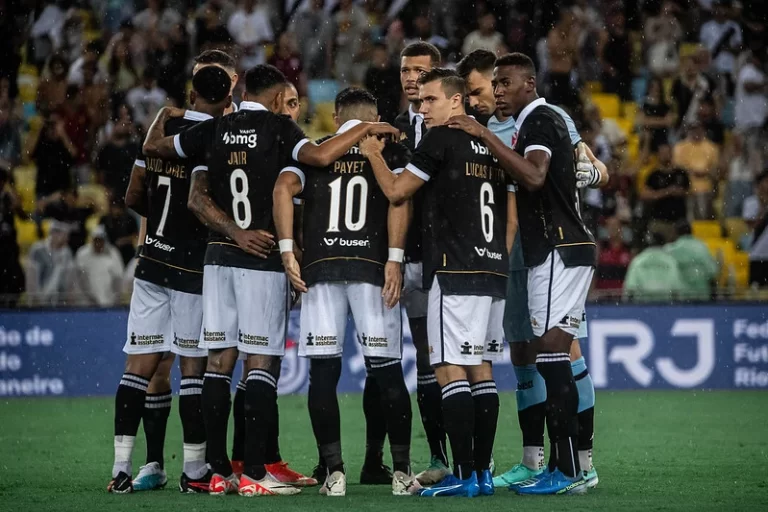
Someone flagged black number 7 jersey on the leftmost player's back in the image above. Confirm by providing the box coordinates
[135,114,211,293]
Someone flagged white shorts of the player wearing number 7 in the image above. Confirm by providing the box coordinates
[123,279,202,357]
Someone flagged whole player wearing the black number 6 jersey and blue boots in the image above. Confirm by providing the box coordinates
[360,68,512,496]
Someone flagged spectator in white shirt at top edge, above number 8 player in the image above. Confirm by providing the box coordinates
[227,0,275,70]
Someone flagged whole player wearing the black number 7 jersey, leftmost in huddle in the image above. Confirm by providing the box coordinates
[108,64,231,493]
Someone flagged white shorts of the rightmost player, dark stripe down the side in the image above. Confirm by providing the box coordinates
[528,251,595,337]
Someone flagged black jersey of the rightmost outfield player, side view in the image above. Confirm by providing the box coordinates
[515,105,595,267]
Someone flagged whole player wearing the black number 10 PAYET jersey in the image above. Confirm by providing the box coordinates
[274,88,421,496]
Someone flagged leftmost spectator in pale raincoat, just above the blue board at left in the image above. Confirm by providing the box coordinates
[26,222,74,306]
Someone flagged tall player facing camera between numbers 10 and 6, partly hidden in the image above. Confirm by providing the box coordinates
[394,41,450,485]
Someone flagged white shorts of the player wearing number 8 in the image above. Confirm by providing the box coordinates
[200,265,291,356]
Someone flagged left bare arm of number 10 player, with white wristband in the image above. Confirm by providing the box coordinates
[272,172,307,292]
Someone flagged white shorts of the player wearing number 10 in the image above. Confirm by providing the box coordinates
[299,282,403,359]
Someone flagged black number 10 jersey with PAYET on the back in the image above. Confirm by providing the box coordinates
[302,134,409,286]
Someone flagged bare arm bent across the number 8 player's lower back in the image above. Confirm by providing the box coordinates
[187,171,275,259]
